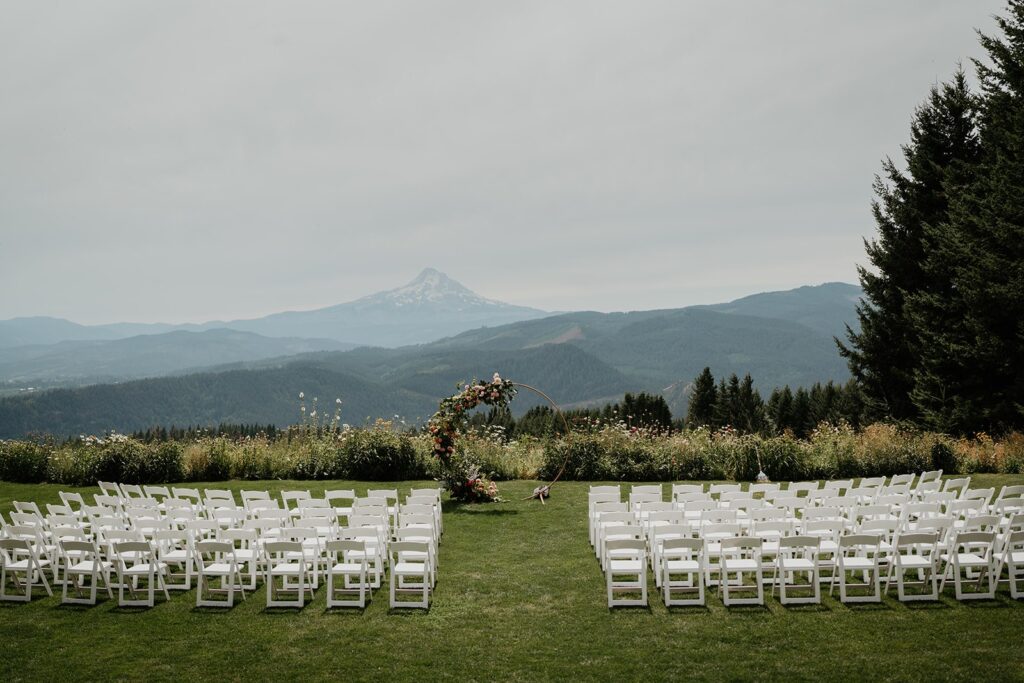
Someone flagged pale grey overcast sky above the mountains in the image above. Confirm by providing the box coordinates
[0,0,1005,323]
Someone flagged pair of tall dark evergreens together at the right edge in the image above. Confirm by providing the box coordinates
[838,0,1024,434]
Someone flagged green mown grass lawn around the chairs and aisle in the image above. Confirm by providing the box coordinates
[0,475,1024,681]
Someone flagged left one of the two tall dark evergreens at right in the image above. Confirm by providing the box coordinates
[839,71,980,419]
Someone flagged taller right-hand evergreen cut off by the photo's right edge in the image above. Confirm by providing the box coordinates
[908,0,1024,432]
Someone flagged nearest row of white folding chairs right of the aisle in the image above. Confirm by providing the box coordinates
[605,530,1024,607]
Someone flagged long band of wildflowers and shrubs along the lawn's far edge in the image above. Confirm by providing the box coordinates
[0,424,1024,485]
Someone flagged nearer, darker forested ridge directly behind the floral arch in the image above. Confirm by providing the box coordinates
[0,346,633,438]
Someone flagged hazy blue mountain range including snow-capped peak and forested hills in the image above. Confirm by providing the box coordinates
[0,269,860,437]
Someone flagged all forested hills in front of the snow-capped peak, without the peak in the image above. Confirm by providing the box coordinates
[0,285,855,438]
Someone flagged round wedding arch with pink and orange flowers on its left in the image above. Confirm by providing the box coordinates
[427,373,569,503]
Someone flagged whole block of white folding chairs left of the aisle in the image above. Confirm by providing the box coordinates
[0,489,440,607]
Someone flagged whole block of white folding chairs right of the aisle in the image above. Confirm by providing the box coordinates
[588,477,1024,605]
